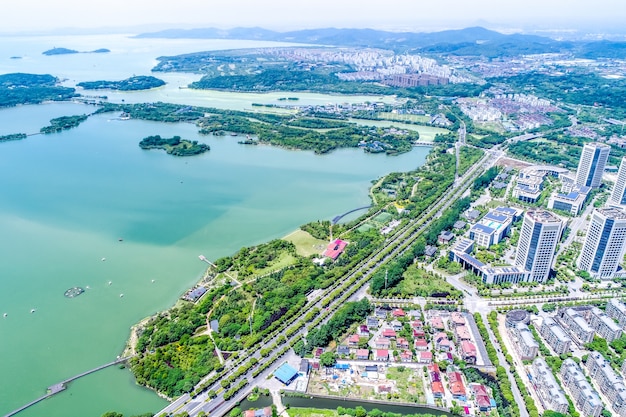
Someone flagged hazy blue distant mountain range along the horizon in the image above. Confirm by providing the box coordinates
[136,27,626,58]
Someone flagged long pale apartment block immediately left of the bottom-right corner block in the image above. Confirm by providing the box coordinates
[561,358,604,417]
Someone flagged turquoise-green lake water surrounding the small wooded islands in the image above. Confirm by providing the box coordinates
[0,37,429,417]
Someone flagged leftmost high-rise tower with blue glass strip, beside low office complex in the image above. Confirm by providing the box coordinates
[515,210,563,282]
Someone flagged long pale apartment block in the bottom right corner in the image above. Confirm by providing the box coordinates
[587,352,626,417]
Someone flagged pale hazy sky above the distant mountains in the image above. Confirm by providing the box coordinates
[0,0,626,32]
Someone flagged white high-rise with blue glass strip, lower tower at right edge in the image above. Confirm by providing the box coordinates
[576,207,626,279]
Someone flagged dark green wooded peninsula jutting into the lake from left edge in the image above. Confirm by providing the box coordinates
[0,73,78,108]
